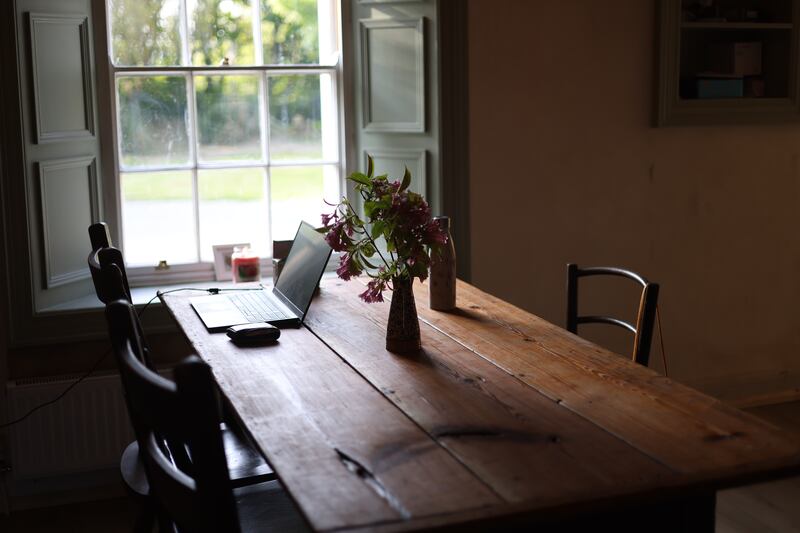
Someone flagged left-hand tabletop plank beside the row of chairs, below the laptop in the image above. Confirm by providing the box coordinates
[159,293,501,530]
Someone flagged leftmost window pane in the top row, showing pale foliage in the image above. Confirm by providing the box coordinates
[108,0,181,65]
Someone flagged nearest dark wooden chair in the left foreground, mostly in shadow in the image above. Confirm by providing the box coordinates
[106,300,308,532]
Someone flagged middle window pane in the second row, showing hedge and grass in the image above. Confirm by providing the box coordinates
[194,76,262,161]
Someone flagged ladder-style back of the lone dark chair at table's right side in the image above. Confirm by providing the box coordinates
[567,264,658,366]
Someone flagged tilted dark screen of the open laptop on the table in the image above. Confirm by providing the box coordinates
[275,222,332,319]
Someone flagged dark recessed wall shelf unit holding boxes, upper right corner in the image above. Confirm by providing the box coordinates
[655,0,800,126]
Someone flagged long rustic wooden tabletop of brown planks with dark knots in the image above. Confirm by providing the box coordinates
[163,278,800,531]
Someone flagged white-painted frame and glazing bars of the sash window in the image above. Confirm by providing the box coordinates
[103,0,348,287]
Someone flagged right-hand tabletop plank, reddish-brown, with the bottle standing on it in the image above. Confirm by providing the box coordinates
[415,280,800,483]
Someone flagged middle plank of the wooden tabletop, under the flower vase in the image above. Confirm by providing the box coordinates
[306,280,674,508]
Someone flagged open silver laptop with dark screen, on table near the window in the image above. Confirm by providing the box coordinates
[189,222,333,332]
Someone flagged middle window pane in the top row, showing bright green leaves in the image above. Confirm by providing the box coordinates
[186,0,255,65]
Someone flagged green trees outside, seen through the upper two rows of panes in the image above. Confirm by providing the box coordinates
[109,0,321,165]
